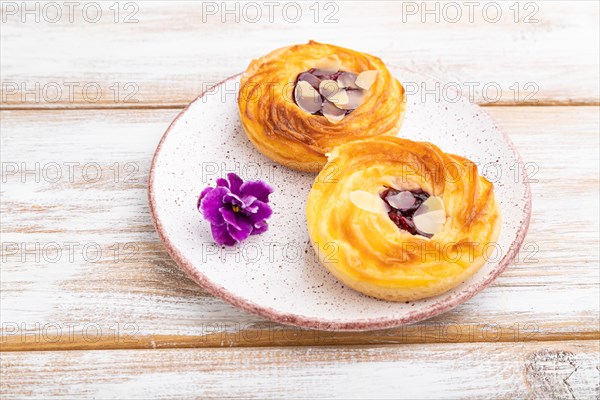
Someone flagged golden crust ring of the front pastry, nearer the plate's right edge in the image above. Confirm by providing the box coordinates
[306,137,501,301]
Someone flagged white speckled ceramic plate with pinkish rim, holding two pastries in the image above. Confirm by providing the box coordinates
[148,69,531,330]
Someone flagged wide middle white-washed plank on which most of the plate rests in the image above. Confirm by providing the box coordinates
[0,107,600,351]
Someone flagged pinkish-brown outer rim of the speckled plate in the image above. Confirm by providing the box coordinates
[148,73,531,331]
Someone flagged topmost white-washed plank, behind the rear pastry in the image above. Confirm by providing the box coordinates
[0,1,600,108]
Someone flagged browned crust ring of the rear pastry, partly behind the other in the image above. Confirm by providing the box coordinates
[238,41,406,172]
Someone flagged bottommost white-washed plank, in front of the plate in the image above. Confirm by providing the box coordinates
[1,341,600,399]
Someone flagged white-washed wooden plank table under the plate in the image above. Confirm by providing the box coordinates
[0,1,600,399]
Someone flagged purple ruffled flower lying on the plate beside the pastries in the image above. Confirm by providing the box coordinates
[198,173,273,246]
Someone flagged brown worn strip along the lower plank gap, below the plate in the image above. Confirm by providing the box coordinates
[0,325,600,352]
